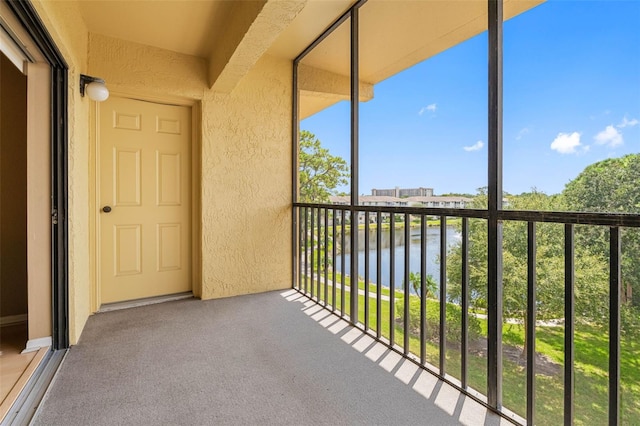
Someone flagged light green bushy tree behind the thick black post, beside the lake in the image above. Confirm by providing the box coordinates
[448,190,608,353]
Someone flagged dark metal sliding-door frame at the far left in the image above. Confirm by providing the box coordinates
[6,0,69,350]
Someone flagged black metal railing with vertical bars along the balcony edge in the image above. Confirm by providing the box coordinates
[293,203,640,425]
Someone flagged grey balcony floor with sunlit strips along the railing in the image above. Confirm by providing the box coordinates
[33,290,510,425]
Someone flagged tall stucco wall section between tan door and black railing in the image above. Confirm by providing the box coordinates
[202,56,291,298]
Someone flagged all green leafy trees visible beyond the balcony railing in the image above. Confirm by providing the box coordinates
[299,130,640,336]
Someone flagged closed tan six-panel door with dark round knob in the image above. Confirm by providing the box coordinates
[97,96,191,303]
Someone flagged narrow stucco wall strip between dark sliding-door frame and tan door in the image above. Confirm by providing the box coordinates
[32,0,91,344]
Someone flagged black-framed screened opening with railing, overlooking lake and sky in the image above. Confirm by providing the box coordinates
[292,0,640,425]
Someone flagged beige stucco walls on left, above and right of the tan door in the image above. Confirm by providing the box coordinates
[20,5,291,344]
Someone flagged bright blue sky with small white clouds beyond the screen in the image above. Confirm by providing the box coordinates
[300,0,640,194]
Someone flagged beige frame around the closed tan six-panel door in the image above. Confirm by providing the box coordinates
[89,92,202,313]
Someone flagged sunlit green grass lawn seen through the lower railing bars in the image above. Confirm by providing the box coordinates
[300,276,640,425]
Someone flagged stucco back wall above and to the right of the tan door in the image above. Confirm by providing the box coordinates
[89,34,291,299]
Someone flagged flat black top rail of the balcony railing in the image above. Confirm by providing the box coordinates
[293,203,640,228]
